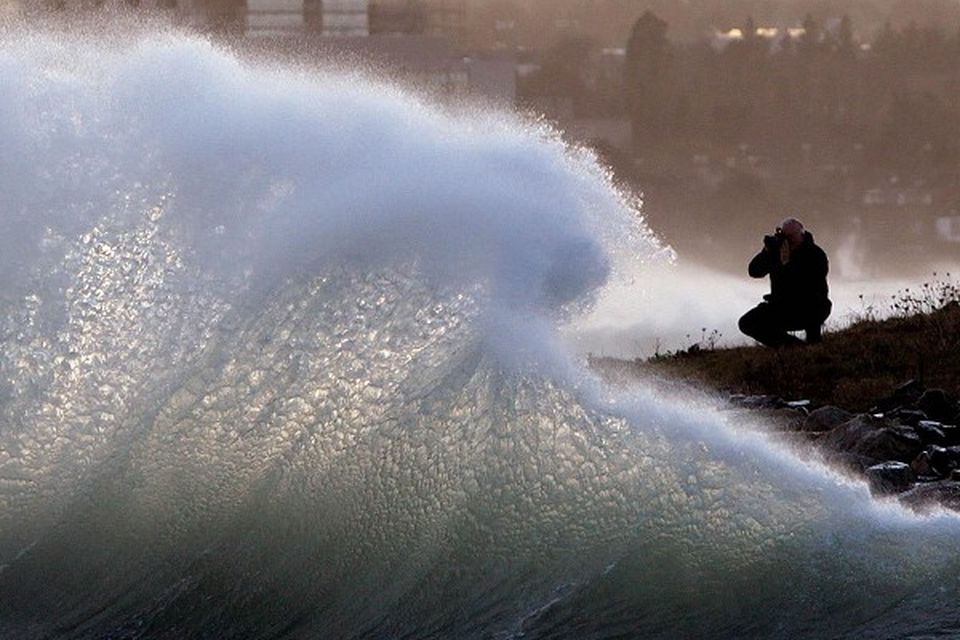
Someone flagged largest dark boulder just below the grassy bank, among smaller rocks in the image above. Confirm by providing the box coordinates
[820,414,923,462]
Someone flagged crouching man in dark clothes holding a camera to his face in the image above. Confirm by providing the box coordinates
[740,218,832,347]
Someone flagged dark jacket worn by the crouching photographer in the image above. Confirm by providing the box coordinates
[747,231,832,321]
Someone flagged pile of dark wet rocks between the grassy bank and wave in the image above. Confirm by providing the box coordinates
[730,380,960,512]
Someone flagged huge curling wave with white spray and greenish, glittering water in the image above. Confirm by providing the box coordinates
[0,23,960,639]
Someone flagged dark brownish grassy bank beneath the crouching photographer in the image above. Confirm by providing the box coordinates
[593,274,960,411]
